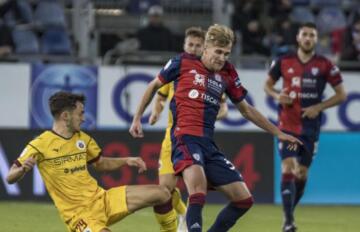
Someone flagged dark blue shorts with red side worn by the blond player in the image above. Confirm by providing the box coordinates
[171,135,243,187]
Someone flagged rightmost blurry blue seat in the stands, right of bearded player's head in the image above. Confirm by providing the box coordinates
[316,7,346,34]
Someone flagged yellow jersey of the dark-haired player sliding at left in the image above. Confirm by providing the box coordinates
[15,131,105,222]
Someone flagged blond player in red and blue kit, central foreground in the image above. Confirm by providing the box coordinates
[129,24,301,232]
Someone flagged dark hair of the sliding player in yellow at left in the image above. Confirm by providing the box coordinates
[49,91,86,118]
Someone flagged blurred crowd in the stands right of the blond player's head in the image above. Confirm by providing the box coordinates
[231,0,360,61]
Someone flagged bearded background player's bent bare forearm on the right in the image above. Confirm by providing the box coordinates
[302,83,346,118]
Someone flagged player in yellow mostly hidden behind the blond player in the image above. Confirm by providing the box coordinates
[149,27,228,232]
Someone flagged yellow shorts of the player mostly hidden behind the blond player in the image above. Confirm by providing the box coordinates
[159,129,175,175]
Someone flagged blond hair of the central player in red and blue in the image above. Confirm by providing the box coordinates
[205,24,235,47]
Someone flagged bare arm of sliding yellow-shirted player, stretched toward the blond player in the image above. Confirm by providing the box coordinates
[93,157,146,173]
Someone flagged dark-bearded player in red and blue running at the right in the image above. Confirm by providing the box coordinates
[264,23,346,232]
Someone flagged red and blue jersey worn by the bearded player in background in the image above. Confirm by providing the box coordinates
[269,54,342,140]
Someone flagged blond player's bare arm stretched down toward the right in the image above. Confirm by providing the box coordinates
[236,99,302,144]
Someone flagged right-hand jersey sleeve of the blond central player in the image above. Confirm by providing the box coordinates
[225,66,247,104]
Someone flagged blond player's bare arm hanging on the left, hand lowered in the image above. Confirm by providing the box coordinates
[129,78,164,138]
